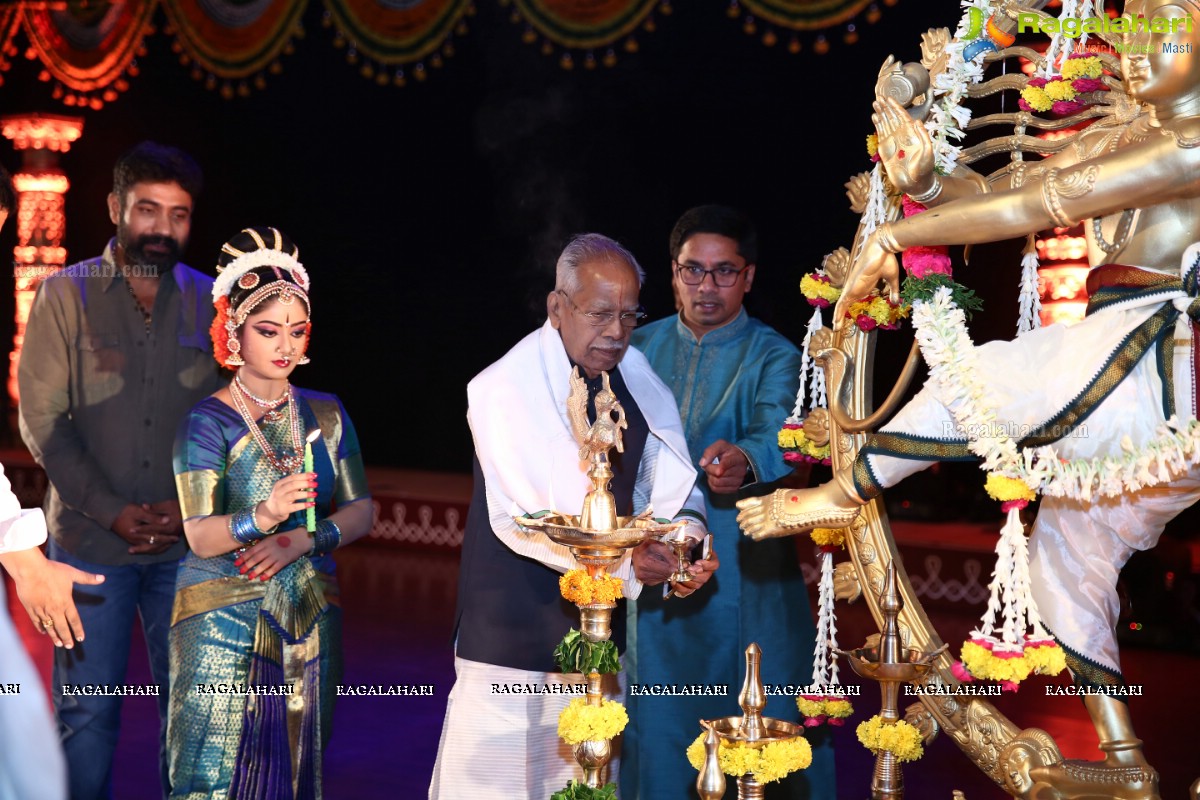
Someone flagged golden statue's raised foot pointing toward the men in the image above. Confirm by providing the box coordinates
[737,480,862,541]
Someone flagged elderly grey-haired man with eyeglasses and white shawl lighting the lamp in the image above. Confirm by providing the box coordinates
[430,234,718,800]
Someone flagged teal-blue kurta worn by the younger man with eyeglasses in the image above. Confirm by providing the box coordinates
[620,309,835,800]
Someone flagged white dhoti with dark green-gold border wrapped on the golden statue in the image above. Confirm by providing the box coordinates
[856,263,1200,684]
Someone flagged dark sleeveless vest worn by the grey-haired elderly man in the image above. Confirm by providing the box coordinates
[455,368,649,672]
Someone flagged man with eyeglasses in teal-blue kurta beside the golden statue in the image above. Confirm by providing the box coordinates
[620,205,835,800]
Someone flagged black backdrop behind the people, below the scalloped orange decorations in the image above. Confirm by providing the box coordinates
[0,0,1019,470]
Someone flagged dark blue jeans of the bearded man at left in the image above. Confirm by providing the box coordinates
[49,539,179,800]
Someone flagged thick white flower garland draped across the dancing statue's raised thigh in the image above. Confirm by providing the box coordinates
[912,287,1200,503]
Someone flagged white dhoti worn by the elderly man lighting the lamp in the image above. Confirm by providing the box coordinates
[430,656,625,800]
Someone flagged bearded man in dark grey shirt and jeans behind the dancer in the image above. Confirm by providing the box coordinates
[18,142,222,800]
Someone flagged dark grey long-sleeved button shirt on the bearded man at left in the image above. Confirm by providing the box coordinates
[17,241,223,565]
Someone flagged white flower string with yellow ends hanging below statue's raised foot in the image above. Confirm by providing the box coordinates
[796,528,854,728]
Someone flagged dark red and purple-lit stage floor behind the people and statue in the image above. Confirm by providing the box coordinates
[96,542,1200,800]
